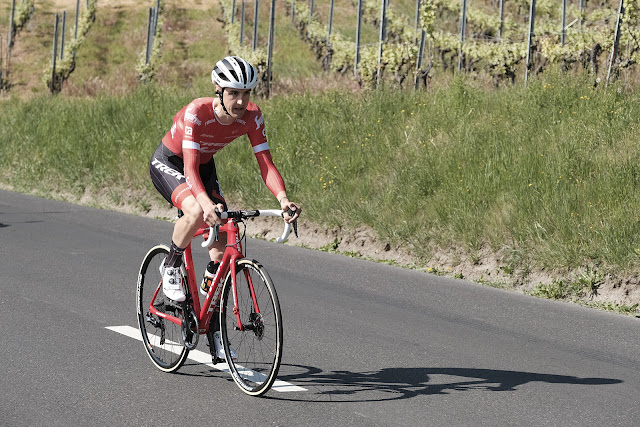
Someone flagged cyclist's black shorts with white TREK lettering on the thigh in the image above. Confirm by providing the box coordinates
[149,143,227,210]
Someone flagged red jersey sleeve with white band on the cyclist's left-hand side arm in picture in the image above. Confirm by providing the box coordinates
[182,103,205,197]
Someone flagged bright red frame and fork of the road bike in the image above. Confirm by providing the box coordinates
[149,218,260,334]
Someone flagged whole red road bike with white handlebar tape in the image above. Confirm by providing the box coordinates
[136,210,297,396]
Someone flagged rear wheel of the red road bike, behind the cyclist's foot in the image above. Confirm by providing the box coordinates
[136,245,189,372]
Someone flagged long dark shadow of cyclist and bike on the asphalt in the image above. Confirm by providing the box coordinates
[268,365,623,402]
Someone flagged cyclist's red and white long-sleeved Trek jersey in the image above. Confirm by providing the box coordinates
[162,98,285,197]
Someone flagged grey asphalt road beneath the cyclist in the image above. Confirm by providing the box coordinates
[0,191,640,426]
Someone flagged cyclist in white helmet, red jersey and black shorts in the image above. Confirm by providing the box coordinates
[150,56,302,356]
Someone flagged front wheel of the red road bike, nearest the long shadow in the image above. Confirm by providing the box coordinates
[220,259,283,396]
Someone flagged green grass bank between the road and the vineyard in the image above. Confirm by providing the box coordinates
[0,71,640,281]
